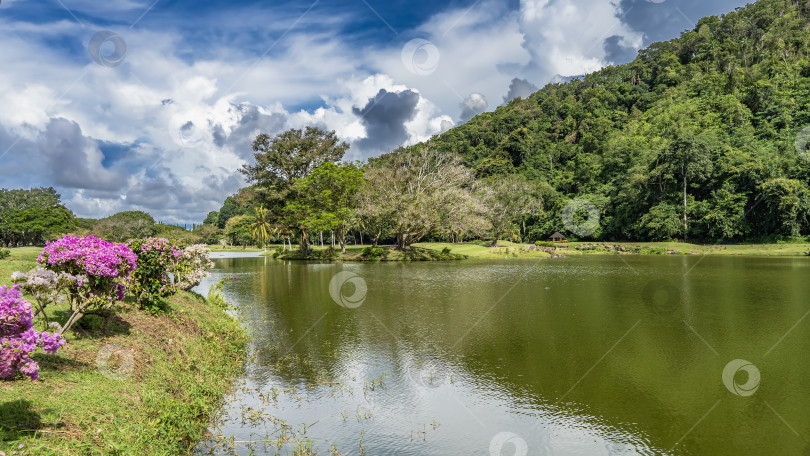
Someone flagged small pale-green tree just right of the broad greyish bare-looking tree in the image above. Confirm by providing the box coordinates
[477,174,539,246]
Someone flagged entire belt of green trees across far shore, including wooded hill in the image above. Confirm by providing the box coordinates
[0,0,810,250]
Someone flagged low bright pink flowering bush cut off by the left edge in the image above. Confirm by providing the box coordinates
[0,285,65,380]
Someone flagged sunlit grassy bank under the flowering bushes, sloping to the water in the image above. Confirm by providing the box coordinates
[0,249,247,455]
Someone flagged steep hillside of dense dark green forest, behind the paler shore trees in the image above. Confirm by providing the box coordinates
[429,0,810,241]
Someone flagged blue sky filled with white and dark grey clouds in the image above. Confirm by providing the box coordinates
[0,0,745,224]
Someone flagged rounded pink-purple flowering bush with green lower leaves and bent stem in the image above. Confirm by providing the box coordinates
[37,236,137,331]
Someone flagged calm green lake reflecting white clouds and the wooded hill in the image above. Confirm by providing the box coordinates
[195,255,810,456]
